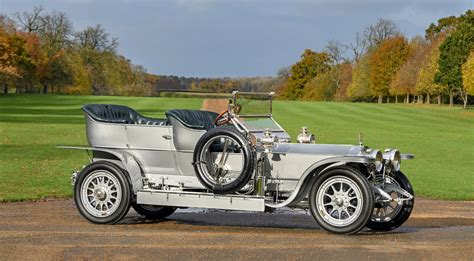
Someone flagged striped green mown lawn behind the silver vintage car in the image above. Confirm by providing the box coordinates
[0,95,474,201]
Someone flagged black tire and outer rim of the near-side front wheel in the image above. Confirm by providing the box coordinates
[309,167,374,234]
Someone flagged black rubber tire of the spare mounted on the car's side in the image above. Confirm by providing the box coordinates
[193,126,255,194]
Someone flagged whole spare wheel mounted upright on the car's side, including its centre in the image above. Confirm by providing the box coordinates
[193,126,255,194]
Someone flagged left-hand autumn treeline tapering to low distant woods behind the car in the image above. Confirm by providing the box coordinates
[0,7,279,96]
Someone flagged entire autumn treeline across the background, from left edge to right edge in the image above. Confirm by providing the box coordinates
[0,7,474,106]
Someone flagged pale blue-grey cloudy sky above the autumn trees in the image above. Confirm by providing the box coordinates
[0,0,474,77]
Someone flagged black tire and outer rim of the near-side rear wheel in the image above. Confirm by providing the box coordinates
[74,161,131,224]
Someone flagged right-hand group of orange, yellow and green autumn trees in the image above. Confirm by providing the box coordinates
[278,10,474,106]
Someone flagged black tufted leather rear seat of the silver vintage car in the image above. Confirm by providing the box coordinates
[82,104,168,125]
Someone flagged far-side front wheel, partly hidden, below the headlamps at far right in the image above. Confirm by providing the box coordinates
[367,172,415,231]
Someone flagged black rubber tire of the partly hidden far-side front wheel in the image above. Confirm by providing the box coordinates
[367,171,415,231]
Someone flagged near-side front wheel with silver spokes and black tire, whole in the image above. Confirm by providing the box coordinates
[309,167,374,234]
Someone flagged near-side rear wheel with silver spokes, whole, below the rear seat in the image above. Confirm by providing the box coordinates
[74,161,130,224]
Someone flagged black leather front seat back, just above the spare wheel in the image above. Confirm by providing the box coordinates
[166,110,218,130]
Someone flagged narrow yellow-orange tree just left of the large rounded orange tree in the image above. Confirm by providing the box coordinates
[347,52,372,100]
